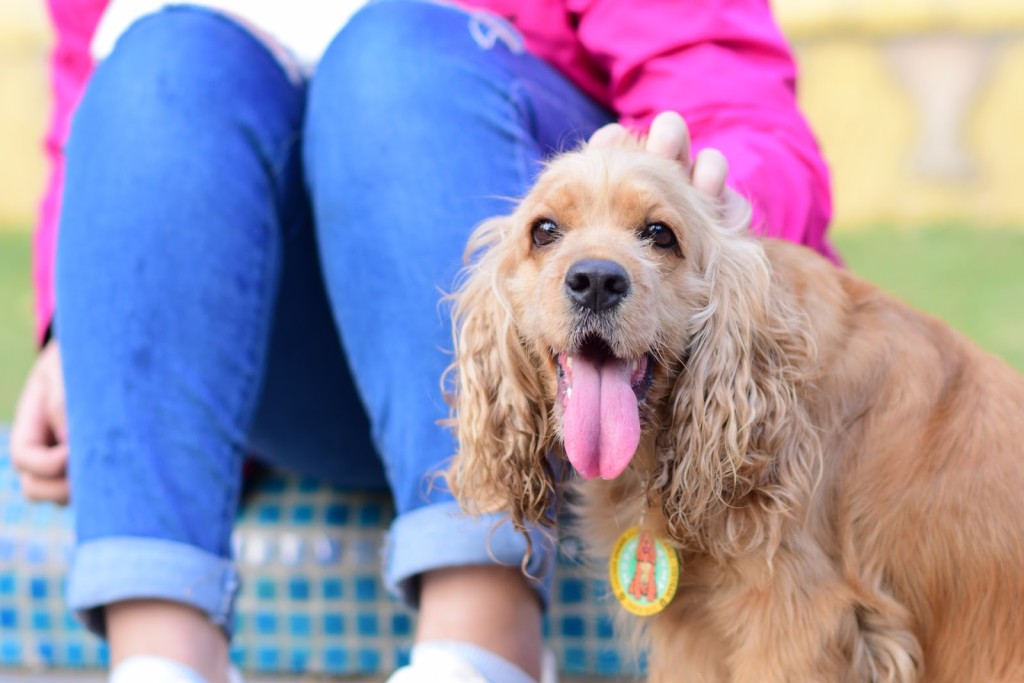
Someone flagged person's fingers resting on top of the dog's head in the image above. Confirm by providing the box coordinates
[589,112,751,219]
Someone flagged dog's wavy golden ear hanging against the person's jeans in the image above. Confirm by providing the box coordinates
[446,218,555,530]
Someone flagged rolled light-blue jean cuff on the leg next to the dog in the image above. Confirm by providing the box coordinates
[384,503,557,608]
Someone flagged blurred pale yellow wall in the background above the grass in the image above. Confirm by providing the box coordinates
[0,0,1024,228]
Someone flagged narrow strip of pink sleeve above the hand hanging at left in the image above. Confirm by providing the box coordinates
[33,0,108,342]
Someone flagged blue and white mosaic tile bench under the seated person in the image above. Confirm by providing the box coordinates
[0,428,637,679]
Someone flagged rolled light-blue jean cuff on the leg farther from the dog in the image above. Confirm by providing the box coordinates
[68,537,240,638]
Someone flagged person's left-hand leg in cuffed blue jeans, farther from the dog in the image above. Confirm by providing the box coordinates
[56,9,307,683]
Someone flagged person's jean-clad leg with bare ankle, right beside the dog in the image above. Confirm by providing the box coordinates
[304,1,610,678]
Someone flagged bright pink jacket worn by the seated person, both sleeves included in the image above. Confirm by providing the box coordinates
[35,0,838,339]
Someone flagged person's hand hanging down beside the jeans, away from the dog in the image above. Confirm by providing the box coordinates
[10,339,71,505]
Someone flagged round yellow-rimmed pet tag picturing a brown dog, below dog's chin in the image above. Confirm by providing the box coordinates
[608,526,679,616]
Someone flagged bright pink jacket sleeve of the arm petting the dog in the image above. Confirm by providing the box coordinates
[568,0,838,260]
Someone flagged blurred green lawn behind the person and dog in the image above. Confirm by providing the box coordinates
[0,225,1024,424]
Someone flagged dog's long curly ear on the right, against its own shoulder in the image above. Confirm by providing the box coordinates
[655,221,820,552]
